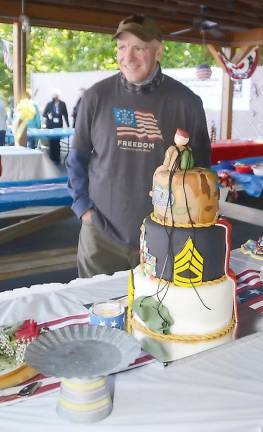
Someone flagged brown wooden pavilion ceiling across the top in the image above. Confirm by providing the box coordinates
[0,0,263,46]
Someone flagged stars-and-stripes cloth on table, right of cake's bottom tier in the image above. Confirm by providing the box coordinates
[236,270,263,312]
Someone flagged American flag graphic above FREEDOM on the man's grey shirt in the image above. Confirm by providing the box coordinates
[113,108,163,141]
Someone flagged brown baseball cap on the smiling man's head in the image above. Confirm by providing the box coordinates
[112,15,162,42]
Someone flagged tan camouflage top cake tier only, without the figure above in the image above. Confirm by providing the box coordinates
[152,166,219,225]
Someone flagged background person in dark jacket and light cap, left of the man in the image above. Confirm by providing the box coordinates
[43,89,69,164]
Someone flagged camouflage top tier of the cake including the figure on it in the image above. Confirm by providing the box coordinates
[150,129,221,226]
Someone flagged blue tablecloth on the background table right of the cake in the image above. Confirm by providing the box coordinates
[212,156,263,198]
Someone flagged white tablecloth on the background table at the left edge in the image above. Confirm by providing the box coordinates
[0,146,60,183]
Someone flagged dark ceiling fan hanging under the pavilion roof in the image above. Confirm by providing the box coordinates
[170,4,246,38]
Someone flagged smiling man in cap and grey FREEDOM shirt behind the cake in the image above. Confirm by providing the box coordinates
[66,15,210,277]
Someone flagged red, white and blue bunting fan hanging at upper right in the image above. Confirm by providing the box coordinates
[218,47,259,80]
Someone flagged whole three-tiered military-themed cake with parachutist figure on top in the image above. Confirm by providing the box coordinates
[128,130,236,359]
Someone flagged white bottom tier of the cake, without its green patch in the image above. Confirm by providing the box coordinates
[132,266,235,342]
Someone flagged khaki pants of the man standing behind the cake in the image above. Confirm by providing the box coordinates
[78,221,139,278]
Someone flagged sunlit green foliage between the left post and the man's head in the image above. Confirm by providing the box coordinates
[27,27,117,74]
